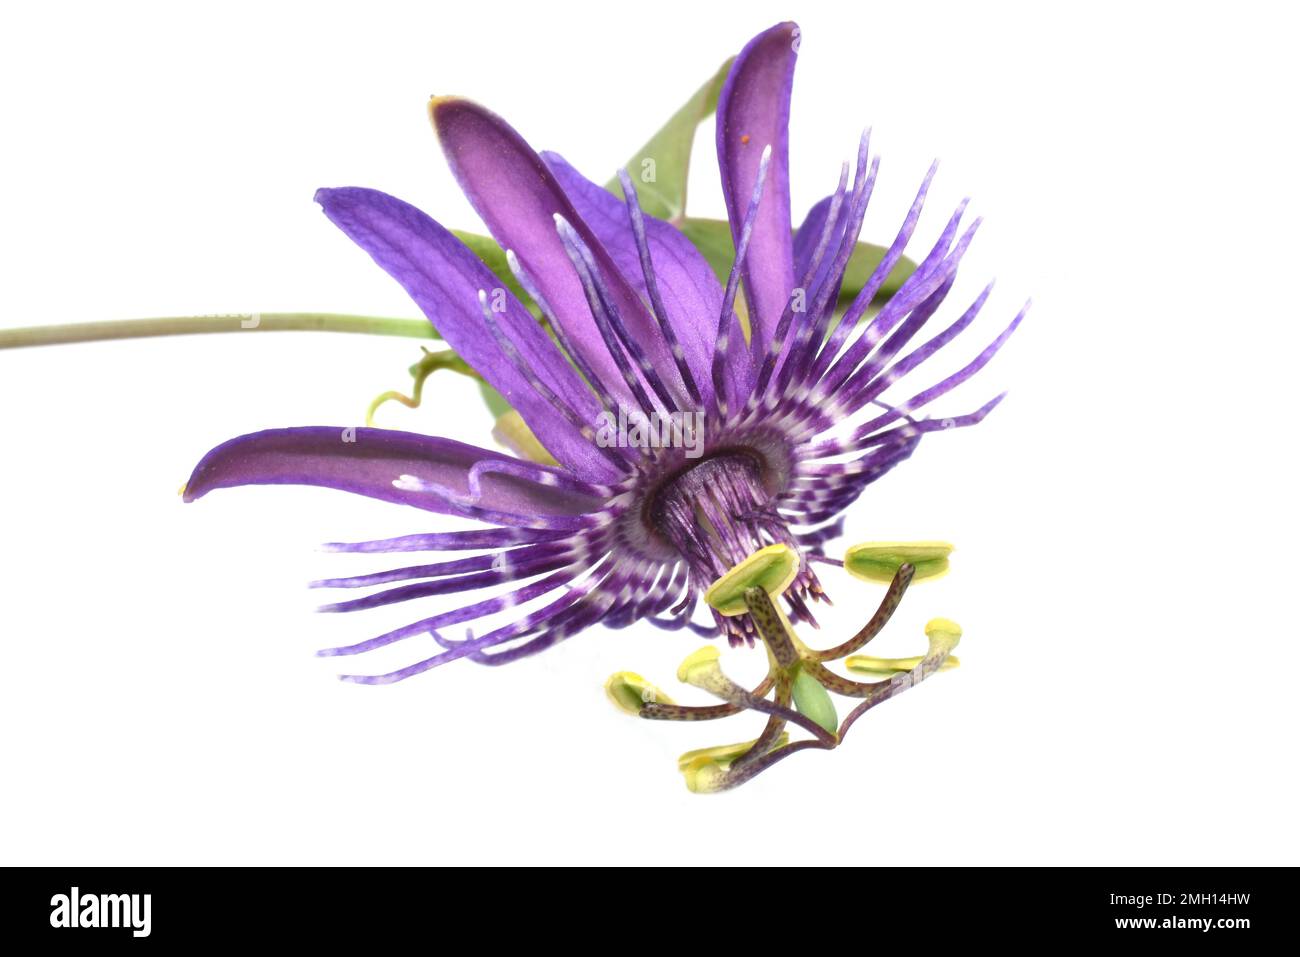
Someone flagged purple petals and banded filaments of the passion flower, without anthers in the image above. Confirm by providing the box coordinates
[185,23,1023,684]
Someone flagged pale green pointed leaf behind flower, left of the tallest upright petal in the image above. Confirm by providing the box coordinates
[605,60,732,224]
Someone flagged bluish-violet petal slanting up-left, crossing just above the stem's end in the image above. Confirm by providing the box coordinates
[316,189,618,480]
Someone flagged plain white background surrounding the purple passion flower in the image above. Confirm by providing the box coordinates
[0,0,1300,865]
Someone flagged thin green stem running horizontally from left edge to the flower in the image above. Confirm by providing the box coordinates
[0,312,438,348]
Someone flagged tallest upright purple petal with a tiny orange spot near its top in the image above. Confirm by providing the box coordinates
[716,23,800,343]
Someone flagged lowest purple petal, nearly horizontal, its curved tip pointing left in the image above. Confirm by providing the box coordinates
[185,425,605,515]
